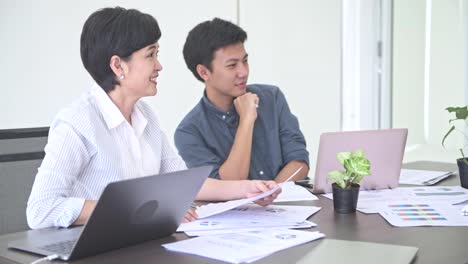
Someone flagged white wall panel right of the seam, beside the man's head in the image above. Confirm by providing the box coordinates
[240,0,341,166]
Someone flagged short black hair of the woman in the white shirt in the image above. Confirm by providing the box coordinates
[80,7,161,93]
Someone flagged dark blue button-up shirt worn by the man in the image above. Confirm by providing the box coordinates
[174,84,309,180]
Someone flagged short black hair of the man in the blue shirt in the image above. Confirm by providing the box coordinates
[184,18,247,82]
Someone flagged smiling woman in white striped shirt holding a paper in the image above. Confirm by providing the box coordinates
[27,7,278,229]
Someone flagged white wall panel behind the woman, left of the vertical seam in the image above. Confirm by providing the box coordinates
[0,0,236,137]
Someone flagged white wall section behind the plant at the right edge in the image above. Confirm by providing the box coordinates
[427,0,466,146]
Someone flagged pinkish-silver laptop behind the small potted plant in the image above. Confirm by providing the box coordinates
[313,128,408,193]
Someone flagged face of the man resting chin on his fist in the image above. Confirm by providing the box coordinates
[205,43,249,99]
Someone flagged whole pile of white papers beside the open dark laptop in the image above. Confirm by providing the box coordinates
[167,167,324,263]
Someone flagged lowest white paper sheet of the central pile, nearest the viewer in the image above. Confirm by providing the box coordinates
[163,229,325,263]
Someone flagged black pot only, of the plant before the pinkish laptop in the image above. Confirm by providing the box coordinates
[332,183,359,214]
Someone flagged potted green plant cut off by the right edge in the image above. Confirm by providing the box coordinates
[442,106,468,189]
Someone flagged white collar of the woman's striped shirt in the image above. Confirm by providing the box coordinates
[91,84,148,136]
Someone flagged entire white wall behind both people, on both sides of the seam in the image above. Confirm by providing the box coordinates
[0,0,341,167]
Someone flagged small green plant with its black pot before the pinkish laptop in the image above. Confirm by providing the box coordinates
[328,149,370,214]
